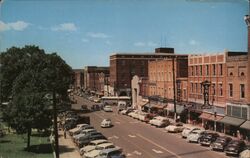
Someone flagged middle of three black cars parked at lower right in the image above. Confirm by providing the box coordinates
[210,136,232,151]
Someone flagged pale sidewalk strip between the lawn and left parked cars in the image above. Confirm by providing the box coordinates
[58,130,81,158]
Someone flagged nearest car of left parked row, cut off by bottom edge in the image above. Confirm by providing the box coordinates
[96,147,125,158]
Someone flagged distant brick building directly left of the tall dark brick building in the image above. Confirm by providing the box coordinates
[84,66,109,96]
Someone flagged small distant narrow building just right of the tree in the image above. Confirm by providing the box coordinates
[73,69,84,90]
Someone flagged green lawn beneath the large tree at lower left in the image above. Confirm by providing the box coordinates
[0,134,53,158]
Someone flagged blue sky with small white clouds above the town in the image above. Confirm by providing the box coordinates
[0,0,248,69]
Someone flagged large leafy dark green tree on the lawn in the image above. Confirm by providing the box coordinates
[0,46,72,149]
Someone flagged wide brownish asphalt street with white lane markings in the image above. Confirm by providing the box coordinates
[73,96,227,158]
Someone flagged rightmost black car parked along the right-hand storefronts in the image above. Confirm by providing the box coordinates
[225,140,246,155]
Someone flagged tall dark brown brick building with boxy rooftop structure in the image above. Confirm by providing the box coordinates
[110,48,180,96]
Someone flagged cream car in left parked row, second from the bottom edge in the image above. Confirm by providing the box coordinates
[84,143,115,158]
